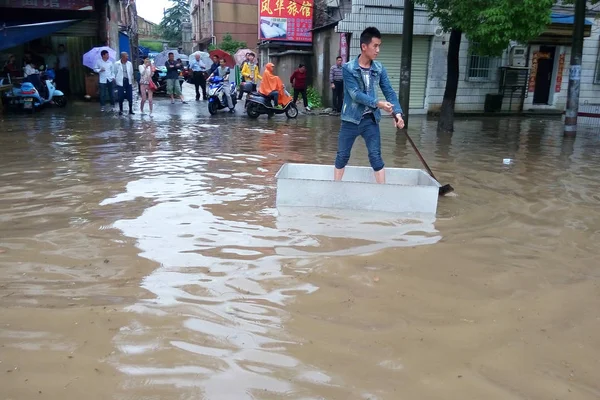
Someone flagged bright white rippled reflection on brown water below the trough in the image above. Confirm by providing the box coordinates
[101,150,440,399]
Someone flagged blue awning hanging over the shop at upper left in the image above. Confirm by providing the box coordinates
[0,19,79,51]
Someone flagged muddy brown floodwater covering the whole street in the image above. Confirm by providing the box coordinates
[0,93,600,400]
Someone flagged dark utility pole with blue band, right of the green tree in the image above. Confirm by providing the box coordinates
[564,0,586,136]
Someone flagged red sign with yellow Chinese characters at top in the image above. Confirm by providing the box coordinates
[258,0,314,42]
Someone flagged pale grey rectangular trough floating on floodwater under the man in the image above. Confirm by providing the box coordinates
[275,163,440,214]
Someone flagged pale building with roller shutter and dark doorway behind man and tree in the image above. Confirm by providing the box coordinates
[336,0,600,114]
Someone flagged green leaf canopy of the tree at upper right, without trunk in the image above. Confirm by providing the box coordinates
[415,0,555,55]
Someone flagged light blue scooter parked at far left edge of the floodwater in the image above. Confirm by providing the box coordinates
[0,69,67,113]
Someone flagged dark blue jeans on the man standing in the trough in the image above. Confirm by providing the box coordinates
[335,114,384,171]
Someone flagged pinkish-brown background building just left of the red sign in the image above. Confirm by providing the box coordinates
[190,0,258,50]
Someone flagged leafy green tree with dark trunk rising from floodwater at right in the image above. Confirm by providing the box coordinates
[414,0,555,132]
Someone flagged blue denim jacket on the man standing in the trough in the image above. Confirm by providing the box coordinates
[342,57,402,125]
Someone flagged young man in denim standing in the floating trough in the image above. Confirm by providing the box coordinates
[334,27,404,183]
